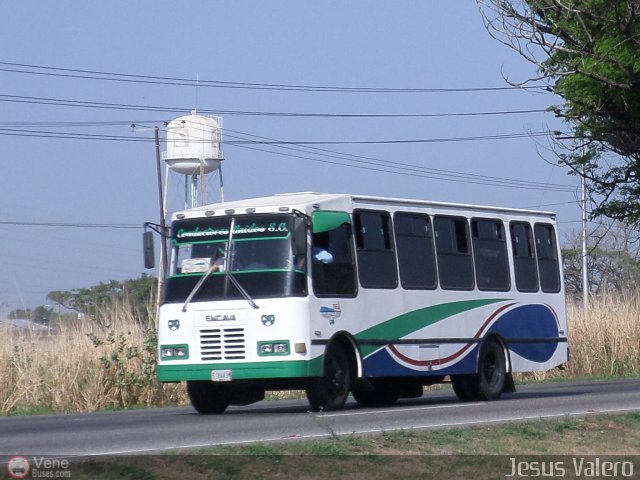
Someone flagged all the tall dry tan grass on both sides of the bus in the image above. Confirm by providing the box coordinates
[0,295,640,415]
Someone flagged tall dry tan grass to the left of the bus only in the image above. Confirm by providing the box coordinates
[0,305,185,415]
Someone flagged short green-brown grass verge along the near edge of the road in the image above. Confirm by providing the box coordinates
[47,412,640,480]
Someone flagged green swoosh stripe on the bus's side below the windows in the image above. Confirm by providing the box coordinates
[355,298,507,357]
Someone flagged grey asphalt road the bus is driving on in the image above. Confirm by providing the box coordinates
[0,379,640,463]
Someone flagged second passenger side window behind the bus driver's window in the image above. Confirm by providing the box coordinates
[393,213,438,289]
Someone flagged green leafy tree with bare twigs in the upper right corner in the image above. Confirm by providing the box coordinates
[477,0,640,224]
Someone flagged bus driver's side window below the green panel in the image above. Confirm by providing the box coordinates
[311,223,356,297]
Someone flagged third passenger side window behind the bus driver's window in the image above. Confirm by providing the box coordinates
[433,215,474,290]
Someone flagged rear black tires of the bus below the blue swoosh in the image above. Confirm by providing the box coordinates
[451,337,507,402]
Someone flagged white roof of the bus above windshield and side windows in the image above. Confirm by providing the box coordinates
[174,192,555,219]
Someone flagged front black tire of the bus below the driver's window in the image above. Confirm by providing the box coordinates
[305,344,351,410]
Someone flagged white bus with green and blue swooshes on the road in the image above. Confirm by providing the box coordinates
[148,193,568,413]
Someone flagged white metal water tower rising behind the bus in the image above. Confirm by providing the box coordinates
[162,112,224,212]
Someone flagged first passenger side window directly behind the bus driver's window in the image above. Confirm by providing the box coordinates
[353,210,398,288]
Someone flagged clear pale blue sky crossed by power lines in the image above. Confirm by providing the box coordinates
[0,0,580,315]
